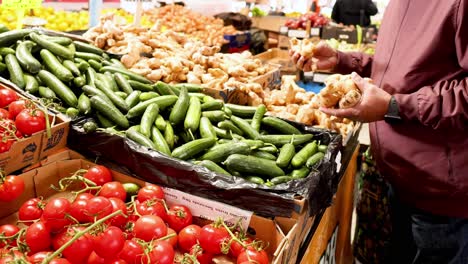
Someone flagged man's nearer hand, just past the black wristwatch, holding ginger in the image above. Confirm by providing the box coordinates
[320,72,392,123]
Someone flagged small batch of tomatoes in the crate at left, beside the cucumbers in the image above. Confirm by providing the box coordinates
[0,88,46,153]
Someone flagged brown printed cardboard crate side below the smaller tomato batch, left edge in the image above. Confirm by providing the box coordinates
[0,83,69,174]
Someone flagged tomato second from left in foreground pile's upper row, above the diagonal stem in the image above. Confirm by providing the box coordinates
[41,197,72,232]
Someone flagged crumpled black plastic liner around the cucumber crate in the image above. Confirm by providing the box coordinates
[68,118,342,217]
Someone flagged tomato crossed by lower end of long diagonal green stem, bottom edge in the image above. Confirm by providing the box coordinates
[52,227,93,263]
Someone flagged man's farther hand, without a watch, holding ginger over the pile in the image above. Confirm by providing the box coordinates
[289,41,338,72]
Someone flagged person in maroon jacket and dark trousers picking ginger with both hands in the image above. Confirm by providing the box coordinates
[292,0,468,263]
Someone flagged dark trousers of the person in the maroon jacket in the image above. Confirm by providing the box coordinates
[387,188,468,264]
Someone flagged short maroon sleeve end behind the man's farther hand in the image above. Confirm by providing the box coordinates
[333,51,373,77]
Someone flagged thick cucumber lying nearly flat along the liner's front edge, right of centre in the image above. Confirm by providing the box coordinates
[224,154,285,178]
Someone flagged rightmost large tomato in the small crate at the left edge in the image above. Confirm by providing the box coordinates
[15,109,46,136]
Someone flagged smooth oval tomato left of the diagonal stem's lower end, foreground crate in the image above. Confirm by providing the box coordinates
[25,221,52,253]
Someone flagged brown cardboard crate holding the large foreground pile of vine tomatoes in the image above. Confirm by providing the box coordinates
[0,150,304,264]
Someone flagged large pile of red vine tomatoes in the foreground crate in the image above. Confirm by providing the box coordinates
[0,165,269,264]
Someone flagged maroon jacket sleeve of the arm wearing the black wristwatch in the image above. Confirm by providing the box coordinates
[394,0,468,129]
